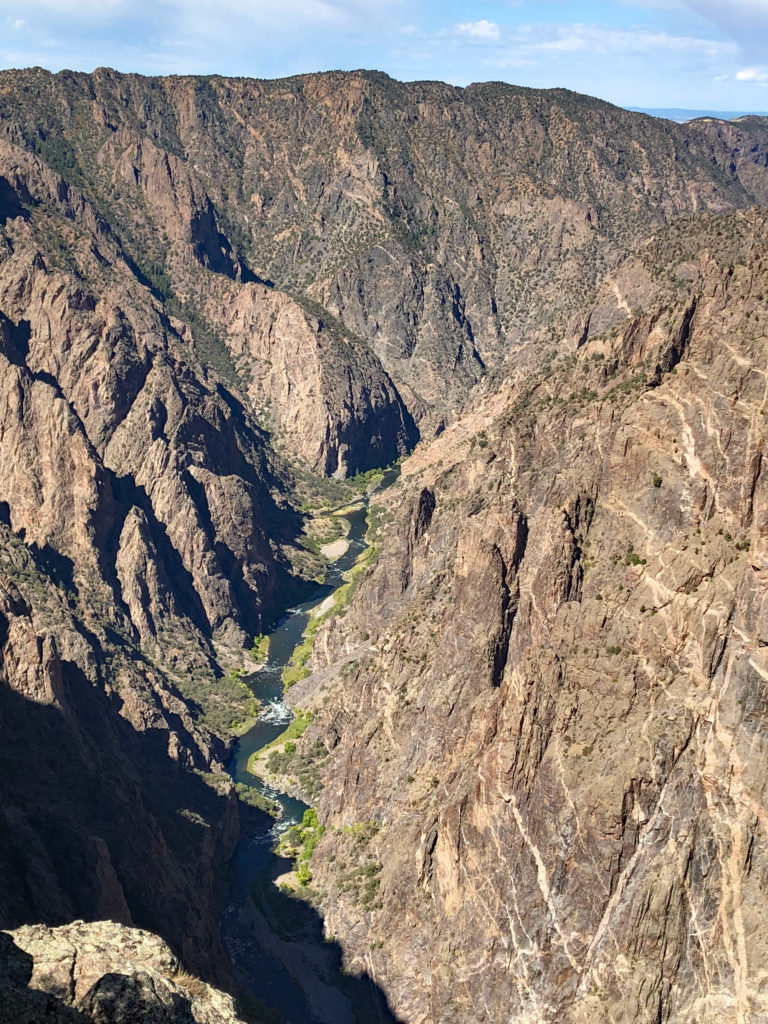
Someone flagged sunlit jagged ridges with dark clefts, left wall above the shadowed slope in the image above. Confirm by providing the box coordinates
[0,134,297,655]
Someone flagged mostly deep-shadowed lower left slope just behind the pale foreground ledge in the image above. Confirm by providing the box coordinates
[0,525,239,980]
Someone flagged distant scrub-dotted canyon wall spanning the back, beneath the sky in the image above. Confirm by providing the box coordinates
[0,69,768,458]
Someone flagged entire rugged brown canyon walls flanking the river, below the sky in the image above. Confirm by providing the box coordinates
[0,69,768,1024]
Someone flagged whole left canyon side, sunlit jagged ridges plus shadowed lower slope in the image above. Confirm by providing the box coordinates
[0,136,284,978]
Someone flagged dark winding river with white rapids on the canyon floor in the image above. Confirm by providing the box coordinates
[221,467,399,1024]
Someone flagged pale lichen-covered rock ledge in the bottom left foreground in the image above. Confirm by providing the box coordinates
[0,921,246,1024]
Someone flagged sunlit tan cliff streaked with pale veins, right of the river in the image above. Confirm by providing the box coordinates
[289,213,768,1024]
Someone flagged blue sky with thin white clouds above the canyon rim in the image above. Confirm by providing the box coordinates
[0,0,768,111]
